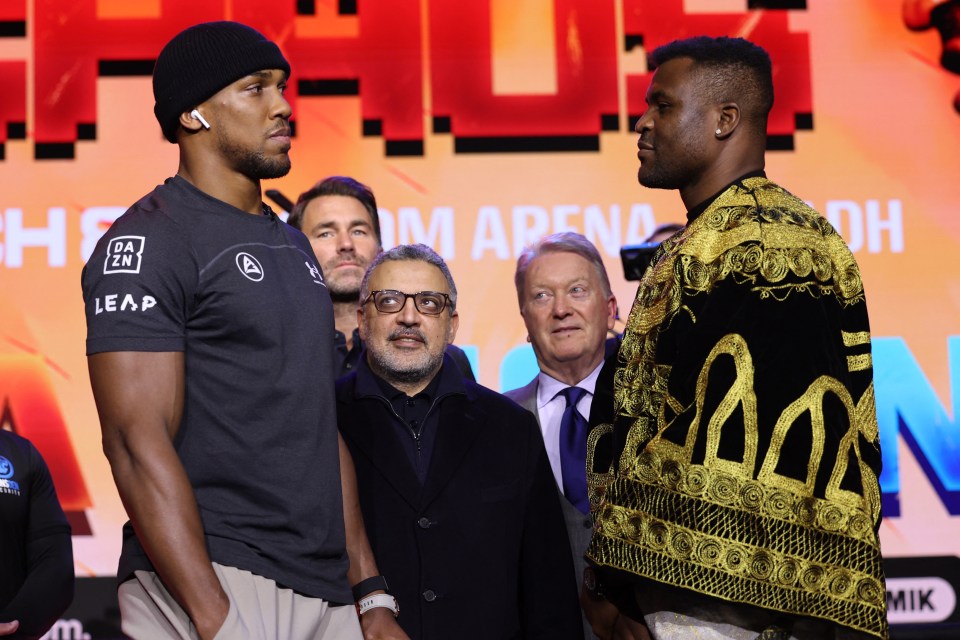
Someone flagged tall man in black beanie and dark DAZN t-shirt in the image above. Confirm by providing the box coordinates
[77,22,405,640]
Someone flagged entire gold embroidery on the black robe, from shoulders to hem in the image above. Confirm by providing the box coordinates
[587,178,886,638]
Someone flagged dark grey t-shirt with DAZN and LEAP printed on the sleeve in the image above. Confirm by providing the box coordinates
[83,177,352,603]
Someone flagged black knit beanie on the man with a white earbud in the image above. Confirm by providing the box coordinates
[153,21,290,142]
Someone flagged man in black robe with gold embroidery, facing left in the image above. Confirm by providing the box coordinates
[584,37,887,640]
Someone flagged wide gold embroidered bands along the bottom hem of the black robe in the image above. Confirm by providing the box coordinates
[590,464,886,632]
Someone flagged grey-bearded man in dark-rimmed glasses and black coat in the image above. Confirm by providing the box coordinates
[337,245,583,640]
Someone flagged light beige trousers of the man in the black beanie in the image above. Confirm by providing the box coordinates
[117,562,362,640]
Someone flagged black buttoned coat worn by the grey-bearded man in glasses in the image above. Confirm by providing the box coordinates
[337,357,583,640]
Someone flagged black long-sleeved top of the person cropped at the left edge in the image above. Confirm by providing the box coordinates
[0,429,73,638]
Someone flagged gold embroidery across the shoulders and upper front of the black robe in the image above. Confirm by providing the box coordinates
[614,178,863,441]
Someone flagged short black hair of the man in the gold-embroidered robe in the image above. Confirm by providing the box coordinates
[650,36,773,129]
